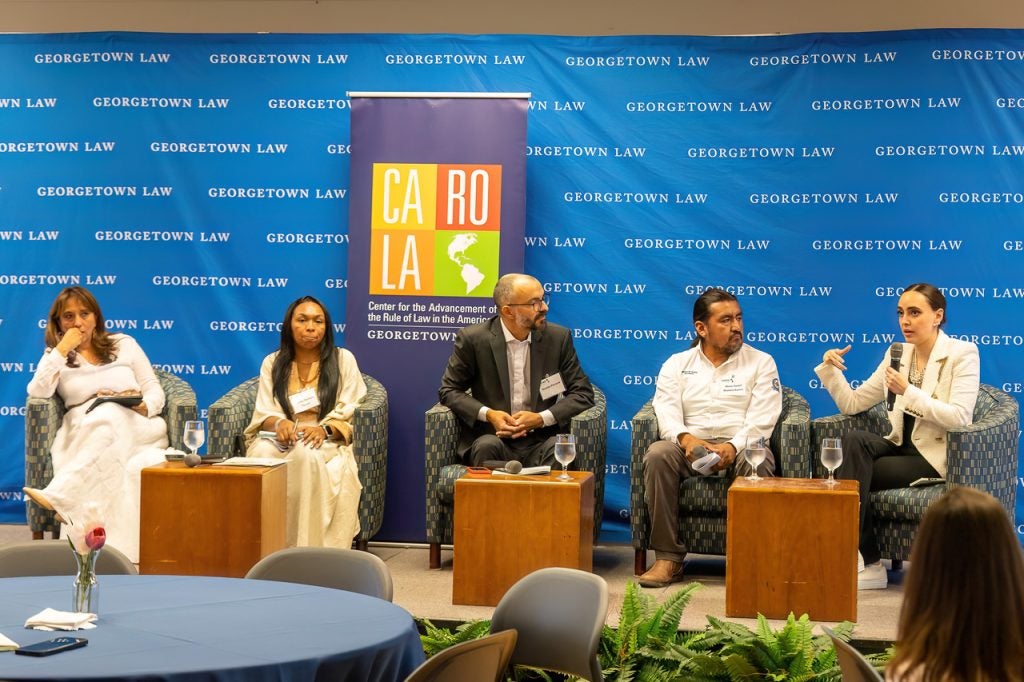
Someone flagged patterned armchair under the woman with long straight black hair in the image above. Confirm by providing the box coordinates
[207,374,388,550]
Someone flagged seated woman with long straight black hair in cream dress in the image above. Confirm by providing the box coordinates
[245,296,367,548]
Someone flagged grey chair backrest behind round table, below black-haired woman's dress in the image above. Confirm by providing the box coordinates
[246,547,394,601]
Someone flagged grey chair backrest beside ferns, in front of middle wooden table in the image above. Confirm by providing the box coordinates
[490,568,608,682]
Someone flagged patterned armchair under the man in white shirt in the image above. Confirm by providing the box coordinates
[630,386,811,574]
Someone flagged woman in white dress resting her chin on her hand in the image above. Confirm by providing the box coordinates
[24,287,167,562]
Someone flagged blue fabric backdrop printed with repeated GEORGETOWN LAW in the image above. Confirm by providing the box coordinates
[0,30,1024,541]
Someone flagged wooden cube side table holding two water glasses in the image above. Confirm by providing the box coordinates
[725,477,860,622]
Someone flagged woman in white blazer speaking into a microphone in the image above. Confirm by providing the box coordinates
[814,284,980,590]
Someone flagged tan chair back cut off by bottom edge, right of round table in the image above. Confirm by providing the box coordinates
[406,630,516,682]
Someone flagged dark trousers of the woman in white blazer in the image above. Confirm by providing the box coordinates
[836,431,939,564]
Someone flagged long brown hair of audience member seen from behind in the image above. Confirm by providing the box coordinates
[889,487,1024,682]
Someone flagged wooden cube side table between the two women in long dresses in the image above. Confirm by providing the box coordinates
[139,462,288,578]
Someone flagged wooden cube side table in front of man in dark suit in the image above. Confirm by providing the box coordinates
[452,470,594,606]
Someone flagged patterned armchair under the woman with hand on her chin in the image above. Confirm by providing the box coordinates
[25,370,199,540]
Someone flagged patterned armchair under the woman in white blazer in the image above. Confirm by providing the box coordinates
[811,384,1020,567]
